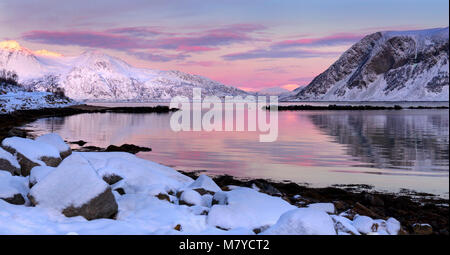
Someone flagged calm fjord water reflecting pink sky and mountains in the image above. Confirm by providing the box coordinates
[27,103,449,197]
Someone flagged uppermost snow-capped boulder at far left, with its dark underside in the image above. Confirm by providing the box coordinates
[2,137,61,176]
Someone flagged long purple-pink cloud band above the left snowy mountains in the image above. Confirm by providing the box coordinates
[22,24,265,52]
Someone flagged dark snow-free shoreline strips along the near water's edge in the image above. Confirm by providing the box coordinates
[0,105,449,235]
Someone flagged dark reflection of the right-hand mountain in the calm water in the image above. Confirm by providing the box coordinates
[309,111,449,171]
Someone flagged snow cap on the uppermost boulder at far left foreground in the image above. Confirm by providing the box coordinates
[2,137,59,165]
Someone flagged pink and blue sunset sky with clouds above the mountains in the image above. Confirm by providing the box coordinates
[0,0,449,91]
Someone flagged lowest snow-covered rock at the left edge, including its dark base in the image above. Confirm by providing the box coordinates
[0,171,28,205]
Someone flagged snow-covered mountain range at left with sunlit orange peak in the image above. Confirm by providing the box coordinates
[0,41,247,101]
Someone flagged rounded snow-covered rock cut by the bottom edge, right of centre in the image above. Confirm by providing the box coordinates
[262,208,336,235]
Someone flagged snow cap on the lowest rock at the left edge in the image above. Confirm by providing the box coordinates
[0,171,28,198]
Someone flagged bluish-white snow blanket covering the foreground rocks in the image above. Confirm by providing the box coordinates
[0,141,406,235]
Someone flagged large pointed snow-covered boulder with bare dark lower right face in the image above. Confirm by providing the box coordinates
[29,154,117,220]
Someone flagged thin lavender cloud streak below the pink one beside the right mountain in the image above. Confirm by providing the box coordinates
[222,48,341,60]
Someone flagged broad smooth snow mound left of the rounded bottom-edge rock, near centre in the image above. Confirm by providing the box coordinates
[208,187,295,229]
